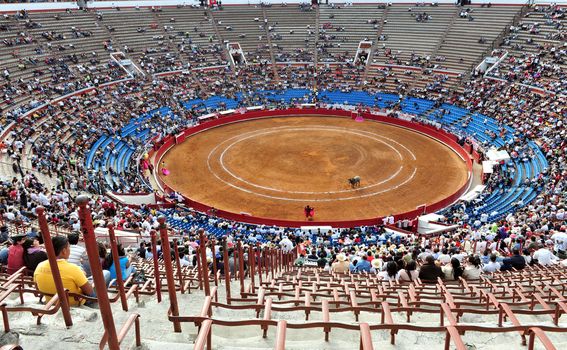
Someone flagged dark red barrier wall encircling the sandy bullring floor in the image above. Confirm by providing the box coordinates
[155,108,472,227]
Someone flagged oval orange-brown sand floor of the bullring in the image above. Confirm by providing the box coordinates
[163,116,467,221]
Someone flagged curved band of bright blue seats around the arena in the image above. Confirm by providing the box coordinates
[86,89,548,224]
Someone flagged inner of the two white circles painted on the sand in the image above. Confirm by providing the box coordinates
[207,126,415,194]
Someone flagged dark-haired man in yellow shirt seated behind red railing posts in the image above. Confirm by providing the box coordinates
[33,236,95,306]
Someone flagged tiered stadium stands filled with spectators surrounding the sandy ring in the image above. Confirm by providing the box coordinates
[0,0,567,350]
